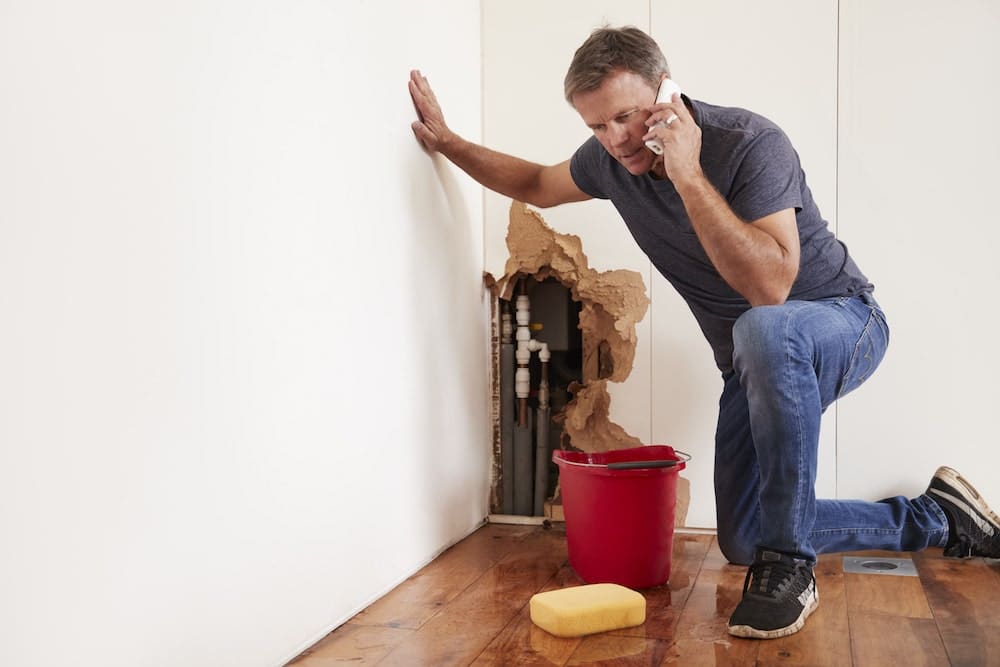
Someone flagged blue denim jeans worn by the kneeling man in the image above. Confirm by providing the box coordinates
[715,294,948,564]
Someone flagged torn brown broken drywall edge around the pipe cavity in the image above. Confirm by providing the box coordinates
[484,201,690,526]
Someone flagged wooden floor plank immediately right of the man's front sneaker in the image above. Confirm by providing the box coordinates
[757,554,851,667]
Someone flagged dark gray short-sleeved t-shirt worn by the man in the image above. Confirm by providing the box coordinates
[570,97,874,373]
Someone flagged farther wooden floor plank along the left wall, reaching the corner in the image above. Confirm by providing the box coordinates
[351,524,535,629]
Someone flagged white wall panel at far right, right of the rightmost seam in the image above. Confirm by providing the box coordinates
[839,0,1000,500]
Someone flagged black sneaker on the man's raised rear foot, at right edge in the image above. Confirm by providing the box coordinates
[927,466,1000,558]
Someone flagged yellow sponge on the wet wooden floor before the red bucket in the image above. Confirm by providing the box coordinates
[529,584,646,637]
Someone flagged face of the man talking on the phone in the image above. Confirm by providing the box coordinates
[573,70,657,176]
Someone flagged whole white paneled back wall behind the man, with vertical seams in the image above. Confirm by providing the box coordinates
[483,0,1000,527]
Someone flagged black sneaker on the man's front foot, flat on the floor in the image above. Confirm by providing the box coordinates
[729,551,819,639]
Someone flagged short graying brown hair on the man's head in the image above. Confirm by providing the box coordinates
[563,25,670,105]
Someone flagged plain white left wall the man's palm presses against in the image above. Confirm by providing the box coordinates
[0,0,489,667]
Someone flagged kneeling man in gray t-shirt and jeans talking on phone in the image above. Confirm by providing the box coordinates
[409,27,1000,638]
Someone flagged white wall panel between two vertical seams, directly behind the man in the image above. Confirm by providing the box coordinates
[651,0,837,526]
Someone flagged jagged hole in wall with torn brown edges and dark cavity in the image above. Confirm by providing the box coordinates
[484,202,689,524]
